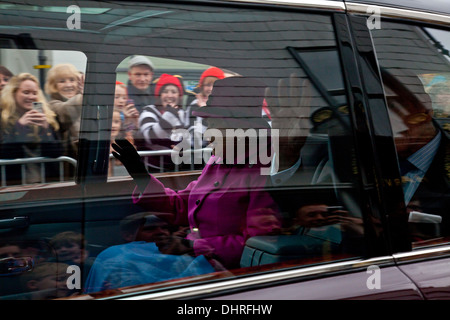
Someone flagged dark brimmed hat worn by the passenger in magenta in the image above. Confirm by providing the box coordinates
[193,77,270,129]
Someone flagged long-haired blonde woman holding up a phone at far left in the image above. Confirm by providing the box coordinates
[0,73,62,184]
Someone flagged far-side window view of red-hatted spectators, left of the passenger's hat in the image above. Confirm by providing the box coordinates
[109,55,214,176]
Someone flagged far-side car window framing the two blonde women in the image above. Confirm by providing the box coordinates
[0,49,86,187]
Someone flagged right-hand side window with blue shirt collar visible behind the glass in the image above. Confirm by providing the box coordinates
[371,21,450,247]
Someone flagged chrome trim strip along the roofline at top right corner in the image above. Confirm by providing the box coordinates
[346,2,450,25]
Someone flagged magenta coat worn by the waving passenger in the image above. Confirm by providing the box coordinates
[133,156,281,269]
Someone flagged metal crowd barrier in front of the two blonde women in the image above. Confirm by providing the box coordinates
[0,156,77,187]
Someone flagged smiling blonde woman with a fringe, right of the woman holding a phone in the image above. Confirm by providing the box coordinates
[45,63,84,158]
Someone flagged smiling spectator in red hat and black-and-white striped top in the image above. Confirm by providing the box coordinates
[139,73,184,171]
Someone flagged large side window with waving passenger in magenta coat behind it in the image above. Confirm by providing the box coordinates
[0,2,366,299]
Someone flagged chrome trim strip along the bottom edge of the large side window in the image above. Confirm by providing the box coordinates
[113,256,395,300]
